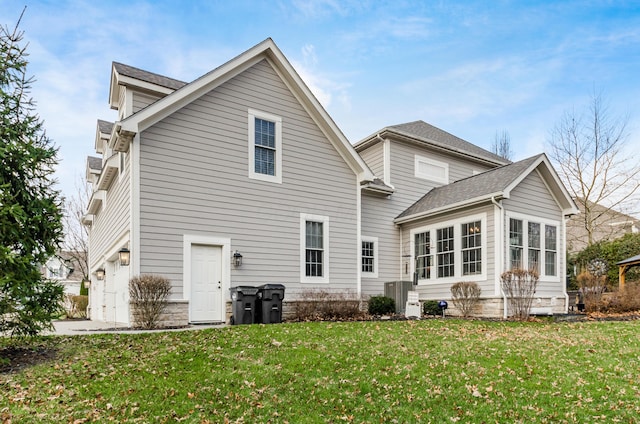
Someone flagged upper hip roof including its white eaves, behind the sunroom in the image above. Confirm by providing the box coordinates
[355,121,511,166]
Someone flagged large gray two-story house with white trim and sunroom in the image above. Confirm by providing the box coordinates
[83,39,576,324]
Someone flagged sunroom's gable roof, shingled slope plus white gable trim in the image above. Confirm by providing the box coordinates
[394,153,578,224]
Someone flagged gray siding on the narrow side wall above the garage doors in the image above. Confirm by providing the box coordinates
[89,153,131,267]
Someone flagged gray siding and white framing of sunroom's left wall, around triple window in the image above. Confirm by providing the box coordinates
[402,204,498,300]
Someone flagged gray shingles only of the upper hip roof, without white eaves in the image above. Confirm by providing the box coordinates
[388,121,509,163]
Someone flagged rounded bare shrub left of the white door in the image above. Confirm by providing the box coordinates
[129,274,171,328]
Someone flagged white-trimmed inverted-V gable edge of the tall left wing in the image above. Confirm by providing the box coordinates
[116,38,374,181]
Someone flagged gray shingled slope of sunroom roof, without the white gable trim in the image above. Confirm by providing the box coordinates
[396,154,542,219]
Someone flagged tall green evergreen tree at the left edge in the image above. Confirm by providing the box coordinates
[0,12,63,335]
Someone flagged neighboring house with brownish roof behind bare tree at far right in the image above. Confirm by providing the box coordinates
[567,198,640,253]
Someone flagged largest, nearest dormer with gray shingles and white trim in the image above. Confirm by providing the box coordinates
[109,62,186,120]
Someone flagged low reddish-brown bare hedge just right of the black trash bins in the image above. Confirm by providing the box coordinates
[292,290,364,321]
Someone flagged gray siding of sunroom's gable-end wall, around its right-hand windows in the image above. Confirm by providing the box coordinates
[503,172,566,294]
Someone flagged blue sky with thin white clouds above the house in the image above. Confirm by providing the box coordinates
[5,0,640,200]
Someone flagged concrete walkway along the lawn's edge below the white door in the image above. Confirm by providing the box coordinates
[50,320,227,336]
